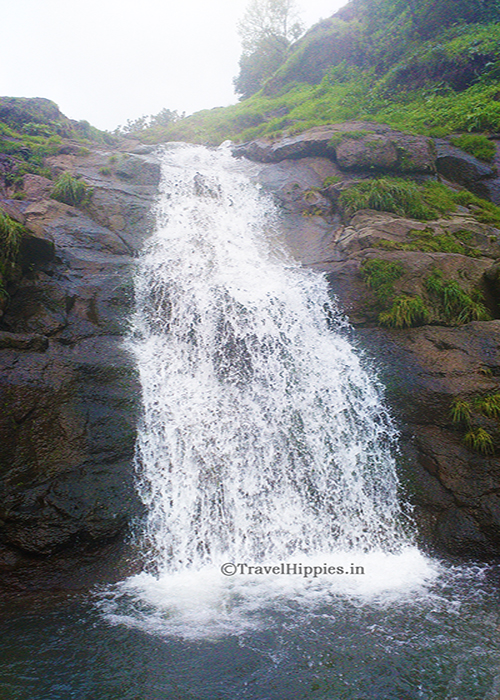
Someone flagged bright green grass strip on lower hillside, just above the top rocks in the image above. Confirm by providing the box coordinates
[132,23,500,148]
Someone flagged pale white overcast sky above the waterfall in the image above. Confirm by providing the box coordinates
[0,0,346,130]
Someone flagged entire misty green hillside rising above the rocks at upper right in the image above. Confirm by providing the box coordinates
[138,0,500,145]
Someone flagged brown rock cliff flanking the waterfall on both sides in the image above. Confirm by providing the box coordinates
[0,110,500,559]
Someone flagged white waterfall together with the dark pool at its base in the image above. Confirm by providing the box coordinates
[0,144,500,700]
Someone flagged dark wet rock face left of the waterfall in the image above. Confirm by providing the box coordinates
[0,141,160,553]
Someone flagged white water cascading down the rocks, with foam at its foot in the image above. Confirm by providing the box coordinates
[98,144,433,634]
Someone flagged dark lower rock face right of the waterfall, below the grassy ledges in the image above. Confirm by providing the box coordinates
[356,321,500,559]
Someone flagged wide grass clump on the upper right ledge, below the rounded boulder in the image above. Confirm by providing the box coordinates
[338,177,455,221]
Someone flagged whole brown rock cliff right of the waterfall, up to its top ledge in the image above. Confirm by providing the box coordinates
[234,122,500,559]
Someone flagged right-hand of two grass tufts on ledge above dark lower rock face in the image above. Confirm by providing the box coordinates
[425,271,491,325]
